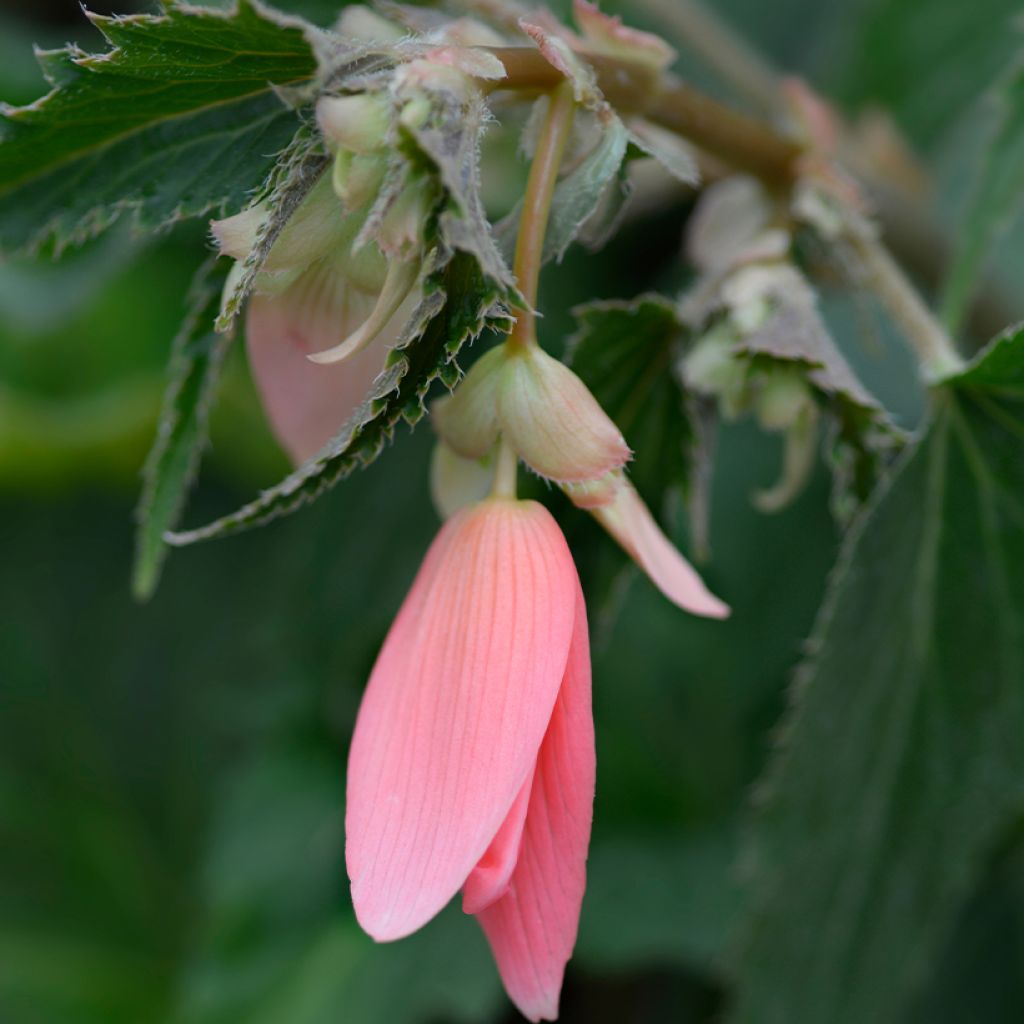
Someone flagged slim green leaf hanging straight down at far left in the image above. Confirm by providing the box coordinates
[132,258,230,600]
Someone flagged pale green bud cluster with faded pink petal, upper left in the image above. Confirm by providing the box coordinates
[212,6,512,463]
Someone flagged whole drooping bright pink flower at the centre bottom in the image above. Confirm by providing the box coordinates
[345,499,595,1021]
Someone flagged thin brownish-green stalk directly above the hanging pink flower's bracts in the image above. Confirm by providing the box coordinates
[509,81,575,345]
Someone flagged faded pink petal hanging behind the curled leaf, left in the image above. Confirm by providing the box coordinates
[246,263,395,464]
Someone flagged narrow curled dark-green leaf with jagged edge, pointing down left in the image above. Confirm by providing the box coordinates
[168,252,507,546]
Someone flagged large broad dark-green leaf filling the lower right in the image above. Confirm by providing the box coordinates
[733,330,1024,1024]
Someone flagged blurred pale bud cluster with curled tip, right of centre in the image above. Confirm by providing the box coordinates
[679,177,819,512]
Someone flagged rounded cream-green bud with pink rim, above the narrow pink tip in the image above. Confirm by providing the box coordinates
[498,345,630,483]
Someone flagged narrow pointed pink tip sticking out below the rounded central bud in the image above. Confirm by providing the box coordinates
[592,477,729,618]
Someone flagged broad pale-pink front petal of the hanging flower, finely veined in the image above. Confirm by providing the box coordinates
[345,500,579,941]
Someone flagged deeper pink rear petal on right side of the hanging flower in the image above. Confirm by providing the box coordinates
[477,582,595,1021]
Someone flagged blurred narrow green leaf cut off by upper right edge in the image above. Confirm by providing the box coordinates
[942,56,1024,332]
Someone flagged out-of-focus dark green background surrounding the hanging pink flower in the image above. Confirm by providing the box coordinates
[0,0,1024,1024]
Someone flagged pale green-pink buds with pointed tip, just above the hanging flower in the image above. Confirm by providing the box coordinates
[433,337,728,617]
